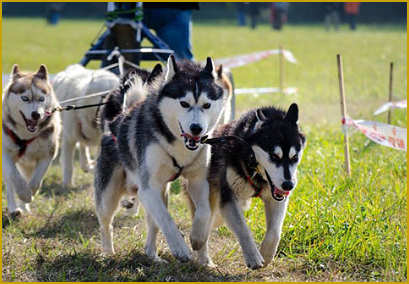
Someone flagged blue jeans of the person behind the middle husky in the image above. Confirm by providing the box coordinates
[143,8,193,60]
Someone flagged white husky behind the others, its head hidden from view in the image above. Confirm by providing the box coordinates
[53,64,119,185]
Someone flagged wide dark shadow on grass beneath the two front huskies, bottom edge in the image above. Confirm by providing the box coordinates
[36,250,239,282]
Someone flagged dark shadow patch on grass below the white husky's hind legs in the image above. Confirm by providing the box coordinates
[26,209,99,239]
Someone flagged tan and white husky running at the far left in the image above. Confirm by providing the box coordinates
[2,64,61,215]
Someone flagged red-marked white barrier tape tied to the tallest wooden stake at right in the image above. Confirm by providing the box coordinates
[342,117,407,151]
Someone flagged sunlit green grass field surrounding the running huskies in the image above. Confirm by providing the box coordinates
[2,19,407,281]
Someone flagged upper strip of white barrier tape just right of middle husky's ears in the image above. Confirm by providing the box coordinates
[214,49,297,68]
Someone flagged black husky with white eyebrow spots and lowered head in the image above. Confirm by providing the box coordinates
[186,104,306,269]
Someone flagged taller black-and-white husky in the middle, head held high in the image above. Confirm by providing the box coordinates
[94,56,223,262]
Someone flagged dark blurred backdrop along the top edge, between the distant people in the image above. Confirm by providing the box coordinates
[2,2,406,25]
